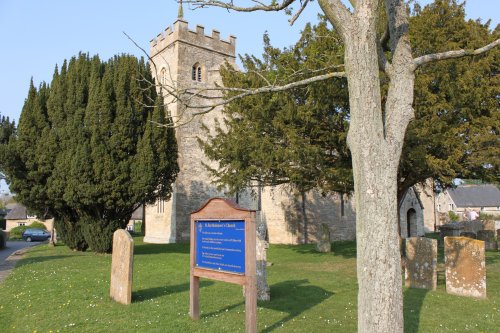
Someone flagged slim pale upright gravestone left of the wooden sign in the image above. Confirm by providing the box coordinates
[109,229,134,304]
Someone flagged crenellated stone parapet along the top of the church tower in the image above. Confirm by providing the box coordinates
[150,19,236,58]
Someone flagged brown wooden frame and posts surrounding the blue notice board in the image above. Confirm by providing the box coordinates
[189,198,257,333]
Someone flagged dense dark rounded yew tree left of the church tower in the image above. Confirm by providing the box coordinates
[0,54,178,252]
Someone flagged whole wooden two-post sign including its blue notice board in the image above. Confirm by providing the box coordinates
[189,198,257,333]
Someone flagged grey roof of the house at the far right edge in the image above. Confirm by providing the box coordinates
[448,184,500,207]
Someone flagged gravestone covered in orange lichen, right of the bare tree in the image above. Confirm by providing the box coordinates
[444,237,486,298]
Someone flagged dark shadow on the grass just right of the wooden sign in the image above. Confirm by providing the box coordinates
[259,279,333,332]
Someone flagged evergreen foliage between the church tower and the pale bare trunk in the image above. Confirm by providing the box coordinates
[202,22,352,194]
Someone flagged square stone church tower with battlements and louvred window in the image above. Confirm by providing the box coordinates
[144,11,236,243]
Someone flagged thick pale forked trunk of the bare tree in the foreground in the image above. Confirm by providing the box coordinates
[345,2,413,333]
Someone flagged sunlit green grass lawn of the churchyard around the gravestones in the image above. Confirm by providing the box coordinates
[0,237,500,333]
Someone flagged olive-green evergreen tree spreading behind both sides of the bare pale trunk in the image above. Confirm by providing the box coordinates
[202,0,500,200]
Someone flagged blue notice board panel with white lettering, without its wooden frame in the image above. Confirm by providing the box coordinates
[195,220,245,274]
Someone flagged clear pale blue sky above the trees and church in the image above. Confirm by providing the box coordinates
[0,0,500,190]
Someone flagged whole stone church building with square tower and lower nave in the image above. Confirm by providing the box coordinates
[144,15,430,244]
